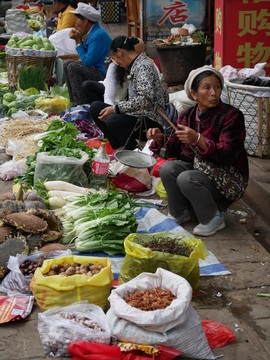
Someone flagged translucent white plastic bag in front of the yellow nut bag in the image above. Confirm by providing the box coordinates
[38,301,111,357]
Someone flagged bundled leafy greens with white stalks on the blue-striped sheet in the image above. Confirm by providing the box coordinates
[59,190,138,255]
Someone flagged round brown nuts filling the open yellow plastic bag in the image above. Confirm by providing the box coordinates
[43,263,104,276]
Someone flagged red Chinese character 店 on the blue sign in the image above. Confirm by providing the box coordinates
[157,0,188,25]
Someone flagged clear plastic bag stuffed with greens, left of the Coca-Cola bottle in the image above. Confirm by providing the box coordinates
[34,151,89,187]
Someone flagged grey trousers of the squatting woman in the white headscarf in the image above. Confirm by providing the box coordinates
[159,160,230,224]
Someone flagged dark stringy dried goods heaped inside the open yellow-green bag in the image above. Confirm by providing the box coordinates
[141,237,193,257]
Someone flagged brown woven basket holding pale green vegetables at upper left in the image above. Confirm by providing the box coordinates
[6,54,55,87]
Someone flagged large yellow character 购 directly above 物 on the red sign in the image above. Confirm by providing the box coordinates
[238,9,270,36]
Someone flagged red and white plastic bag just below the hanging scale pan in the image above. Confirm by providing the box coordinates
[111,166,152,192]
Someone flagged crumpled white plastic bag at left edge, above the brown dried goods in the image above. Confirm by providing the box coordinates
[0,142,26,181]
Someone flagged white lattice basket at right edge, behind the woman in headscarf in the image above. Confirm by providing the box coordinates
[226,77,270,158]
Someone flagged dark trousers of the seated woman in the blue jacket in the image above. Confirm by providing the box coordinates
[63,60,105,106]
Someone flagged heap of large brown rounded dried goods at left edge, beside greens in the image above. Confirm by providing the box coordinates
[0,190,62,276]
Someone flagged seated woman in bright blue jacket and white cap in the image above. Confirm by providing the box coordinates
[64,2,112,106]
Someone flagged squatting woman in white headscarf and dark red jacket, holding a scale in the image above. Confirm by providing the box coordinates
[147,66,248,236]
